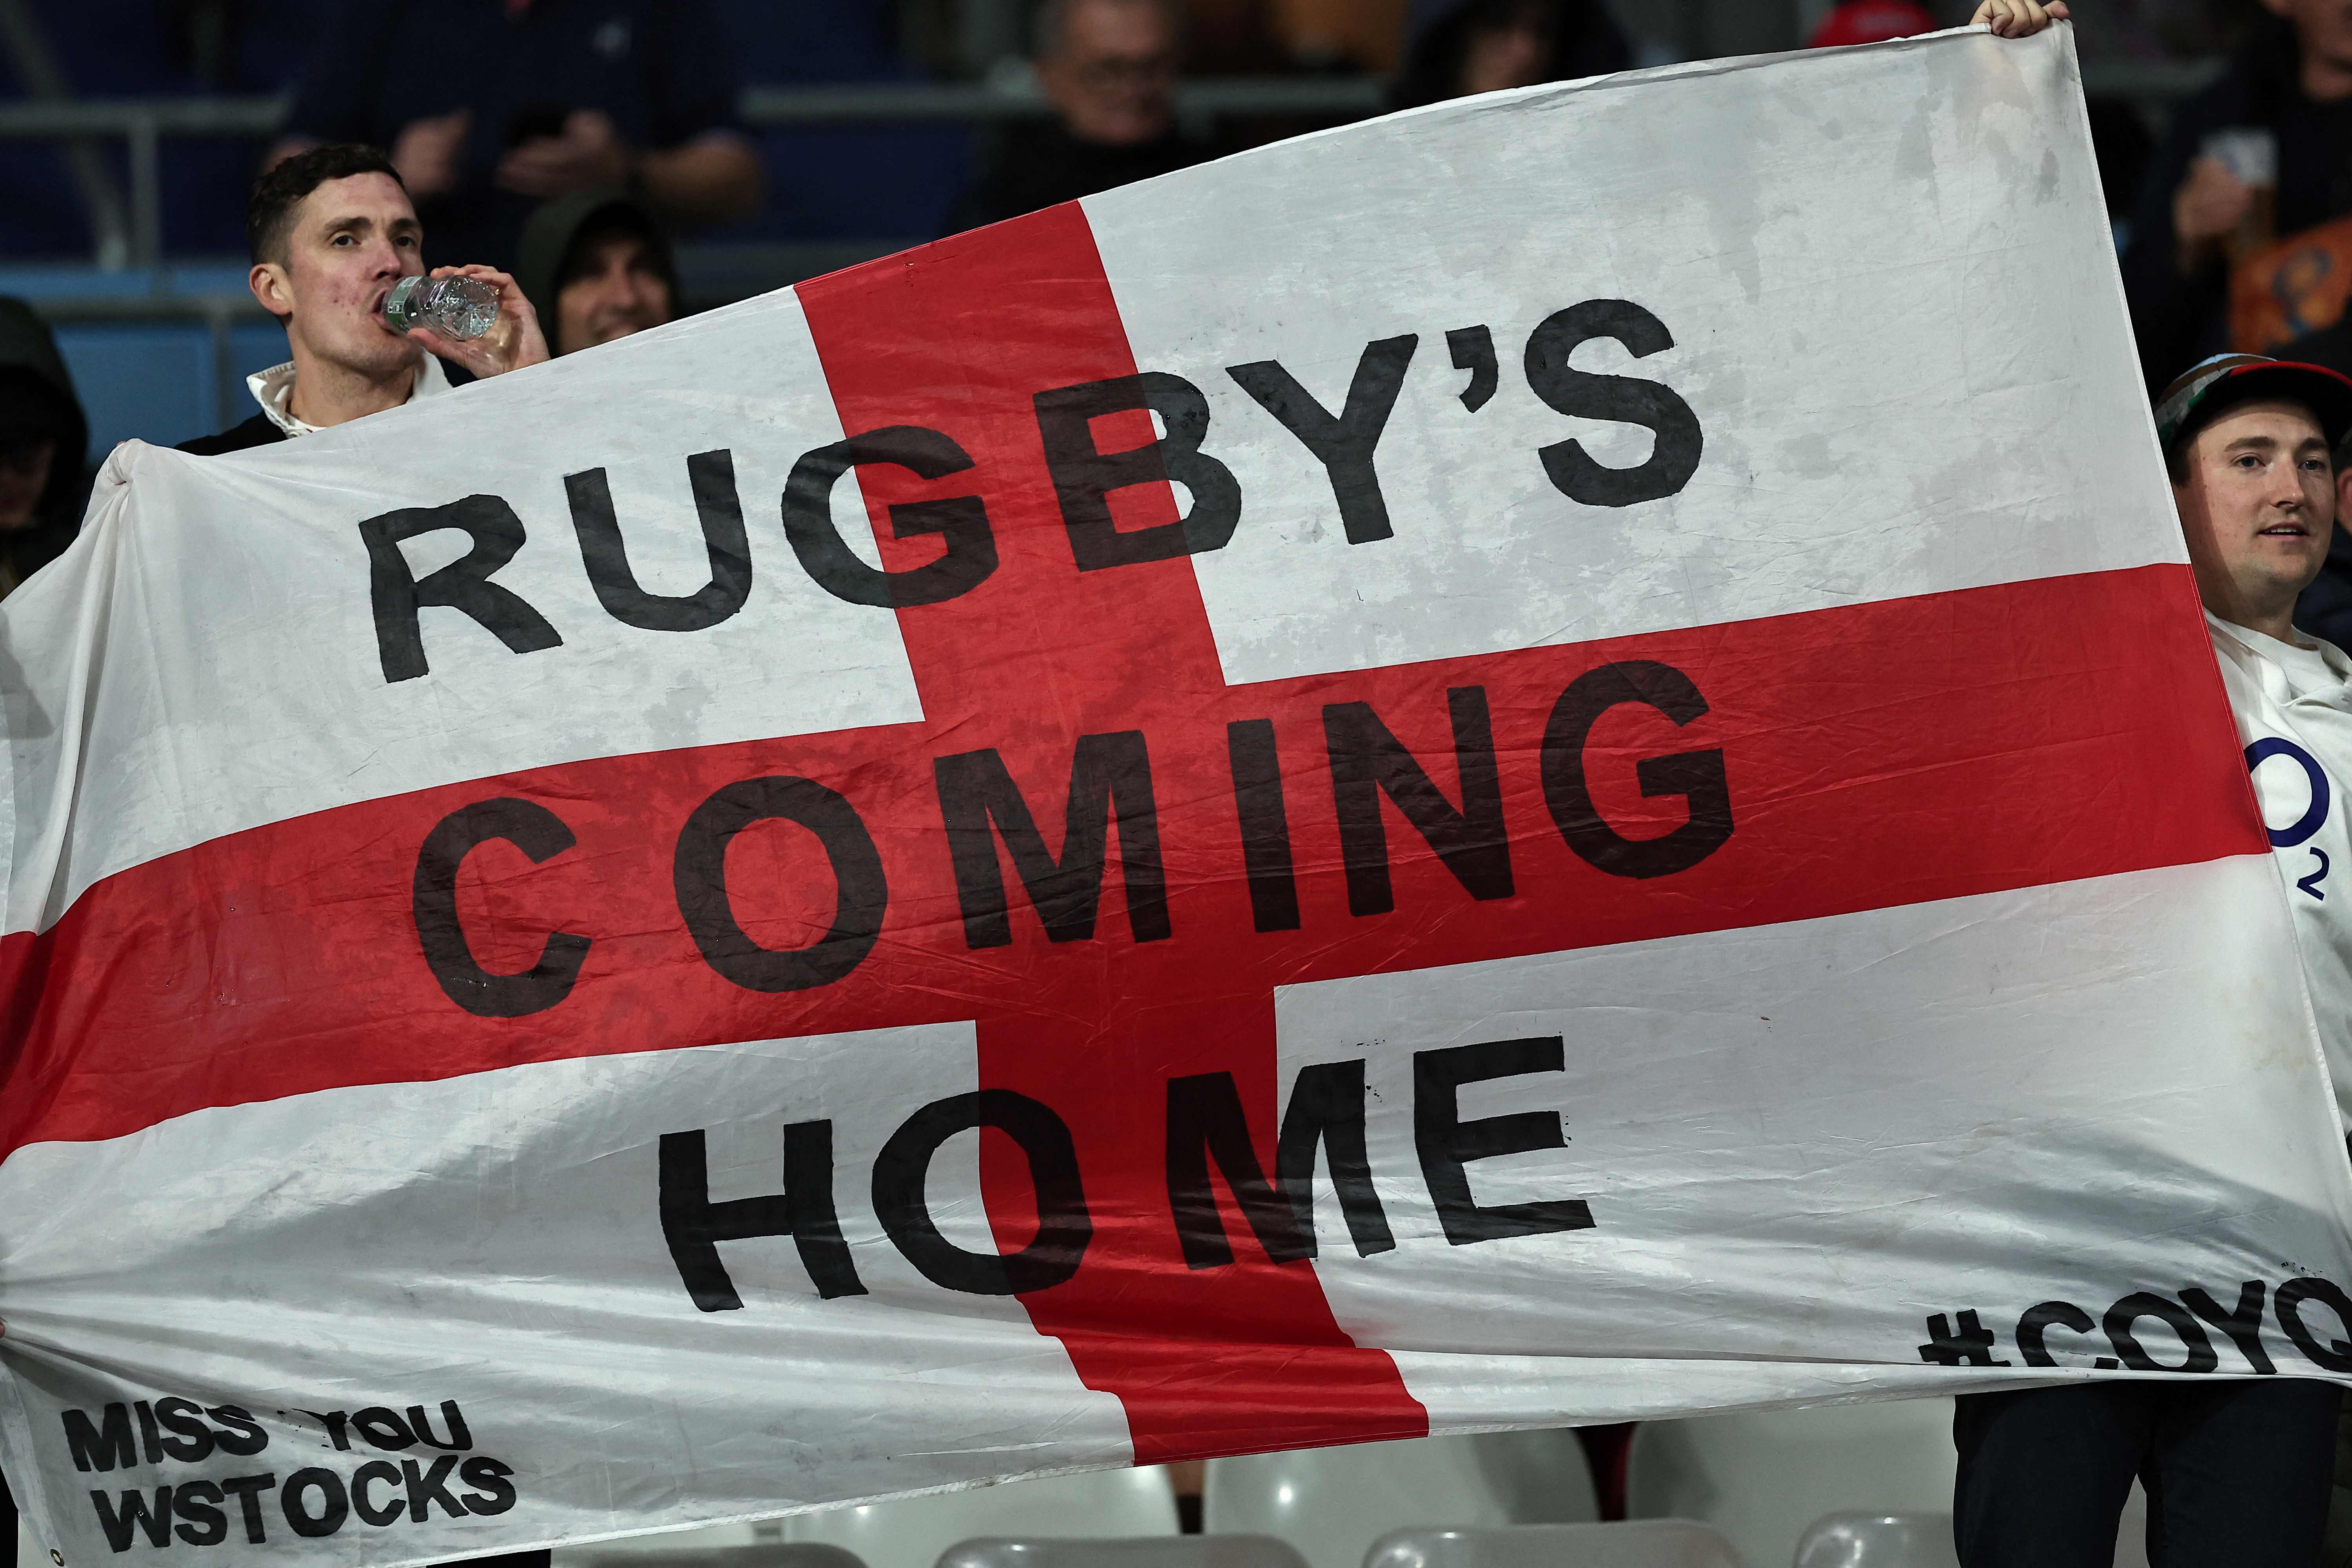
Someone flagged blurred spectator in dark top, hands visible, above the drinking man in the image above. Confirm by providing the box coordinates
[270,0,762,266]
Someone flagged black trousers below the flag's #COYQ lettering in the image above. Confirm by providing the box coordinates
[1952,1377,2343,1568]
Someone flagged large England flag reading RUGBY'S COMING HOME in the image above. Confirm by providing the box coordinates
[0,28,2352,1568]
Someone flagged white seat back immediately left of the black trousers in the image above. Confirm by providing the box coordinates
[1625,1399,1959,1568]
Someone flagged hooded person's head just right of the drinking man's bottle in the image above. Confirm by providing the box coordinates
[515,191,677,355]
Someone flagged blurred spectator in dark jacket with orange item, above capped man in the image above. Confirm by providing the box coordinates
[2124,0,2352,388]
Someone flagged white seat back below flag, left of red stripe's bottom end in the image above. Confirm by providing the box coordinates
[783,1467,1176,1568]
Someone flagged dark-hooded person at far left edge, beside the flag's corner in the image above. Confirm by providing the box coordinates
[0,299,89,602]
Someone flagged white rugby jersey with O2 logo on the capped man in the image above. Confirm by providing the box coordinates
[2206,611,2352,1131]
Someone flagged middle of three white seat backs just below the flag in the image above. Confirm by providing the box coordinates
[1202,1429,1602,1568]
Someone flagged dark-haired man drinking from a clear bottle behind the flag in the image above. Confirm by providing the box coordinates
[181,146,548,456]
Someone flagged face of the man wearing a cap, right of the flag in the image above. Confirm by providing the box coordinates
[2173,402,2336,618]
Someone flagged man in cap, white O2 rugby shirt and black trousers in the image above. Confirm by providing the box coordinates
[1952,355,2352,1568]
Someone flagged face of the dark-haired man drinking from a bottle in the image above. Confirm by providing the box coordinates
[252,174,426,381]
